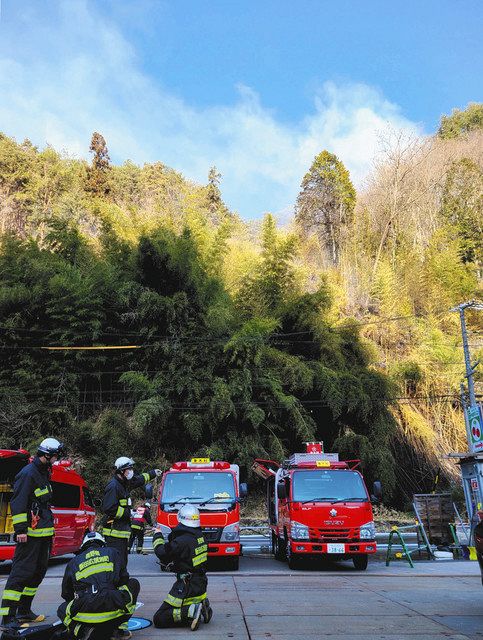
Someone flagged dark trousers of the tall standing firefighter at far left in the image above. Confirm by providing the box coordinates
[0,536,52,617]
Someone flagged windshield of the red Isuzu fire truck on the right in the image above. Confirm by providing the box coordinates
[292,469,368,502]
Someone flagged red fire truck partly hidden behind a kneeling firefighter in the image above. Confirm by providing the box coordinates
[157,458,247,569]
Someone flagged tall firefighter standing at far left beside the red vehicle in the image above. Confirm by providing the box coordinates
[0,438,63,627]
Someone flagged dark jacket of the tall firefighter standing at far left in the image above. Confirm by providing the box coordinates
[10,457,54,538]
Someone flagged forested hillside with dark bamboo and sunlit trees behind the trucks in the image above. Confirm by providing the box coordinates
[0,105,483,505]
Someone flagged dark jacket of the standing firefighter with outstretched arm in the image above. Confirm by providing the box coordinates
[102,469,156,540]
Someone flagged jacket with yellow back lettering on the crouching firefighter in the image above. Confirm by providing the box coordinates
[58,545,135,627]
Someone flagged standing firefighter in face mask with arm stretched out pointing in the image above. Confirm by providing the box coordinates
[102,456,162,568]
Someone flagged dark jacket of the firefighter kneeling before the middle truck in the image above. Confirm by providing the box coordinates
[153,524,208,608]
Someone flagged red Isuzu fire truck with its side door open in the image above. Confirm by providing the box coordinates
[253,443,381,570]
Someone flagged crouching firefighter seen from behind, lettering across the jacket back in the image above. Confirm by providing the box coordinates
[57,531,140,640]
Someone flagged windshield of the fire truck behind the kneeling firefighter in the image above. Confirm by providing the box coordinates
[160,471,235,510]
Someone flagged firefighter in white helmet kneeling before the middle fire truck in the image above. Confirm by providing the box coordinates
[153,504,213,631]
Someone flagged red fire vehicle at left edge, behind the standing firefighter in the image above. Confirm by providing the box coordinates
[0,449,96,562]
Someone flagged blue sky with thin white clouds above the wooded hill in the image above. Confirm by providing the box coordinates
[0,0,483,218]
